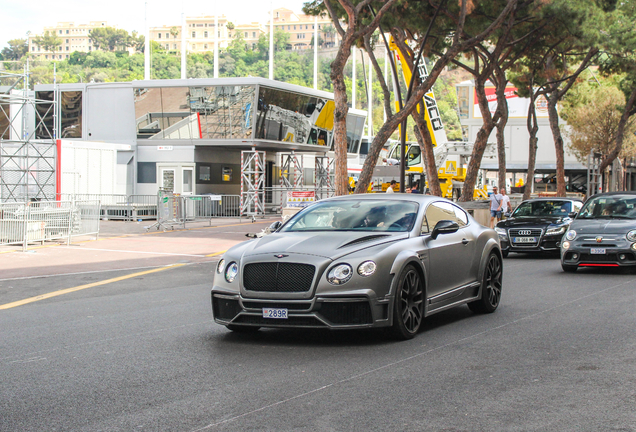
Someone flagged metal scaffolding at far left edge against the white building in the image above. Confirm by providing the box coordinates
[0,68,58,202]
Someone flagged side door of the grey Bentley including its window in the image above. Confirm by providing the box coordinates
[421,201,474,298]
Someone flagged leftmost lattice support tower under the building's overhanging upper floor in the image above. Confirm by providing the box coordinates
[241,148,266,220]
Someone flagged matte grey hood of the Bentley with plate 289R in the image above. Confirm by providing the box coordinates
[238,231,409,259]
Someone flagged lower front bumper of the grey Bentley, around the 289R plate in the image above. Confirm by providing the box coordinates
[212,287,390,329]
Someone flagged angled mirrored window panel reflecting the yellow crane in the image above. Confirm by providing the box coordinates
[256,87,335,147]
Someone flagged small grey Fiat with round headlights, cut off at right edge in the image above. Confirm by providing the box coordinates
[561,192,636,272]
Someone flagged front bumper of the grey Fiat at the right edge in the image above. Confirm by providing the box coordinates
[561,239,636,267]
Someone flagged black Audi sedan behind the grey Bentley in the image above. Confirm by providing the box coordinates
[495,198,583,257]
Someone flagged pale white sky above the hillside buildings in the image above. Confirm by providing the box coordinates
[0,0,307,49]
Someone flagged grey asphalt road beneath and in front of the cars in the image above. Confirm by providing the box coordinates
[0,250,636,432]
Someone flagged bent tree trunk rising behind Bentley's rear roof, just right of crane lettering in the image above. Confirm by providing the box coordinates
[459,76,498,201]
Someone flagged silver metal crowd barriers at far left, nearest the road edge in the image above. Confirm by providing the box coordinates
[0,201,100,251]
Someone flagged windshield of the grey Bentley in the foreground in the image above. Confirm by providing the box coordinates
[281,199,419,232]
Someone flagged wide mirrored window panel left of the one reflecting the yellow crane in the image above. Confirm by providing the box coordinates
[135,86,256,140]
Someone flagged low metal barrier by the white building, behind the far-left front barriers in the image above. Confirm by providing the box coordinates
[62,194,157,221]
